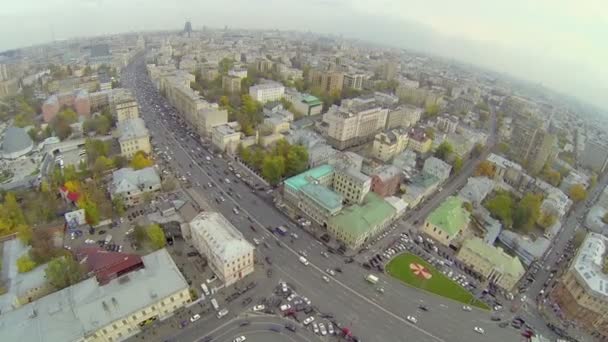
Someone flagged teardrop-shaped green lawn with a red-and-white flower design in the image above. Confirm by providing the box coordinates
[386,253,490,310]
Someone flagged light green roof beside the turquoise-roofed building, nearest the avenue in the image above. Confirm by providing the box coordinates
[330,192,395,236]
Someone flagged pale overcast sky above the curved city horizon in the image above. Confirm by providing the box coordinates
[0,0,608,108]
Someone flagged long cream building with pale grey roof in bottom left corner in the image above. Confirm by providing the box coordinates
[0,249,191,342]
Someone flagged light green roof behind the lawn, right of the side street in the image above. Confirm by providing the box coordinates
[426,196,469,236]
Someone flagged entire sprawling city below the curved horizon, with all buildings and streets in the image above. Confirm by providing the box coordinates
[0,7,608,342]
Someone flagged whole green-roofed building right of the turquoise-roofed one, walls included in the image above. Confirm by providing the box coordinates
[327,192,396,249]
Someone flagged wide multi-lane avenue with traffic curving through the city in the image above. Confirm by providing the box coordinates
[123,58,520,341]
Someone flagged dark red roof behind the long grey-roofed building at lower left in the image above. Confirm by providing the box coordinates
[75,247,144,285]
